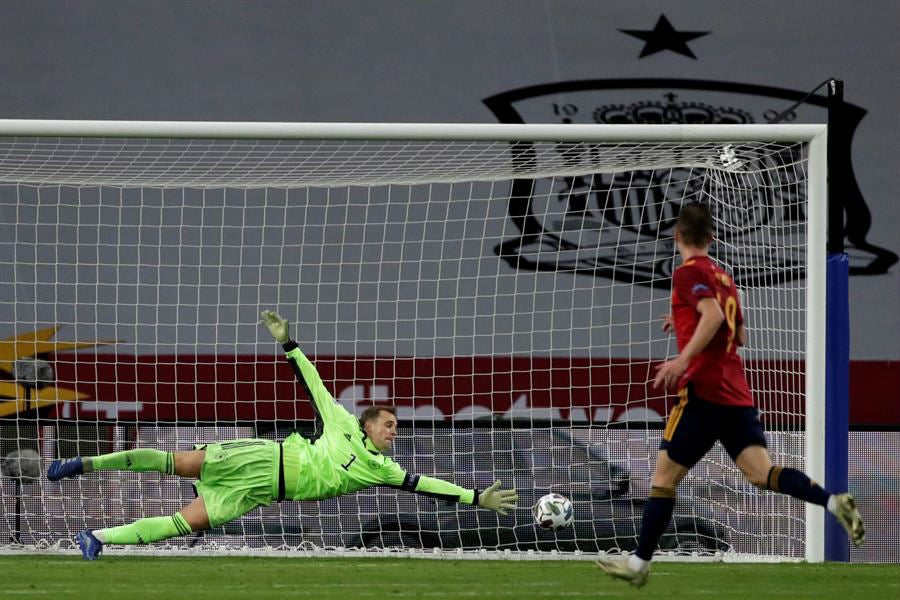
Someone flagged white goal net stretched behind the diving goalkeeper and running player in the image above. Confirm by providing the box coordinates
[0,122,824,559]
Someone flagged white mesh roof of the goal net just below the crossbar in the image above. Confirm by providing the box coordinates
[0,138,796,188]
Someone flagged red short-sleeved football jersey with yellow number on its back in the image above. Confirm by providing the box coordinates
[672,256,753,406]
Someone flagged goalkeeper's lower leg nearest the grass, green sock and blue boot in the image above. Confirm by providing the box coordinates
[75,497,209,560]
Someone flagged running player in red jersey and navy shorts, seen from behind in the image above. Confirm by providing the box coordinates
[598,202,865,587]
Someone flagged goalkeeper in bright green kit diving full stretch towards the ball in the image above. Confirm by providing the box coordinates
[47,310,518,560]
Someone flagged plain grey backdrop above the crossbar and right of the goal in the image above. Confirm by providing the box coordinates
[0,0,900,361]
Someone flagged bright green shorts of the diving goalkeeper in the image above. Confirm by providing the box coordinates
[194,440,279,527]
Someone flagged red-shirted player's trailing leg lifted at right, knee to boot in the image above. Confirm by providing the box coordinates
[734,445,866,547]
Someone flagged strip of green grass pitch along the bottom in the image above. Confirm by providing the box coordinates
[0,555,900,600]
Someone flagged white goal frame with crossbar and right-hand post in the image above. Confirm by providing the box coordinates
[0,119,846,562]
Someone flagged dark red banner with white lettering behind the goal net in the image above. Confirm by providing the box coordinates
[31,353,900,425]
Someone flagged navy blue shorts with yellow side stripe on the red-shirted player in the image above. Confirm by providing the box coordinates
[659,385,766,469]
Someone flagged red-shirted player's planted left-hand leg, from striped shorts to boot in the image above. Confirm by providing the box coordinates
[597,390,715,587]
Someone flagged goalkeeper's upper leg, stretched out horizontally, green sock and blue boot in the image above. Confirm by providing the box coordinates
[47,448,206,481]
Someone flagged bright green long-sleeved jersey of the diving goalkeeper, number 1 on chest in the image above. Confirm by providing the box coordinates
[283,341,478,504]
